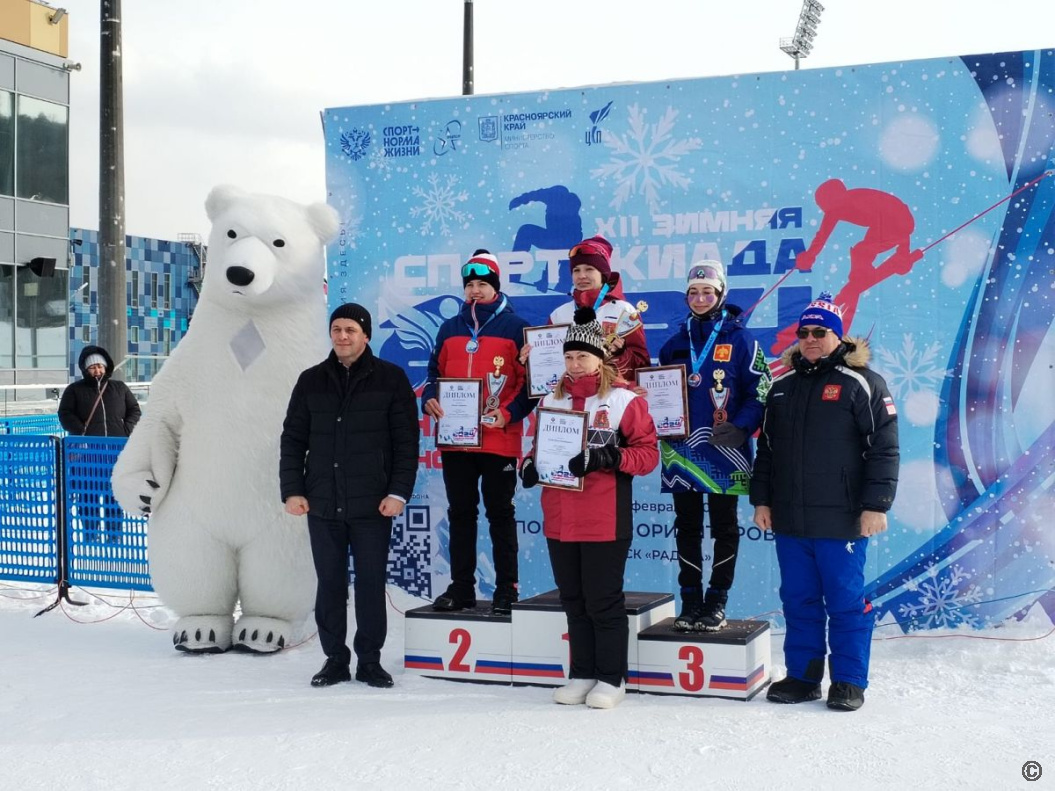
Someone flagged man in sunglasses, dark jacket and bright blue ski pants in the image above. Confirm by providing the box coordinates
[750,294,899,711]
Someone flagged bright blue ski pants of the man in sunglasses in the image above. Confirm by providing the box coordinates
[775,534,875,689]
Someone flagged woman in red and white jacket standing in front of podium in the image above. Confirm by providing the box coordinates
[520,308,659,709]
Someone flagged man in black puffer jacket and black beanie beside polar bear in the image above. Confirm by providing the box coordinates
[279,303,420,687]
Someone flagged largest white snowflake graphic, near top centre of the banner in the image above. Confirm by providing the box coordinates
[590,104,702,212]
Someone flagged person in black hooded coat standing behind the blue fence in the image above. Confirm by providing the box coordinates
[58,346,141,543]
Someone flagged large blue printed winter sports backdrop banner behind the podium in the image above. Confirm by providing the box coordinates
[324,50,1055,630]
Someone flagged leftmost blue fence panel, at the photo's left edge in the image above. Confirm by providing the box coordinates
[0,437,59,582]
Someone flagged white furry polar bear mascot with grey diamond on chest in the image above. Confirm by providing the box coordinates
[113,187,338,654]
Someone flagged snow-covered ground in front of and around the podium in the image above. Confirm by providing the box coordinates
[0,583,1055,791]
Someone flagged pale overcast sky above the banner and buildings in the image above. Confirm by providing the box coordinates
[63,0,1055,239]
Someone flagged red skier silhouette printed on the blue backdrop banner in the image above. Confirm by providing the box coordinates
[771,178,923,354]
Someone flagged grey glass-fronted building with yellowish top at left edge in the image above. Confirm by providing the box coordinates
[0,0,71,384]
